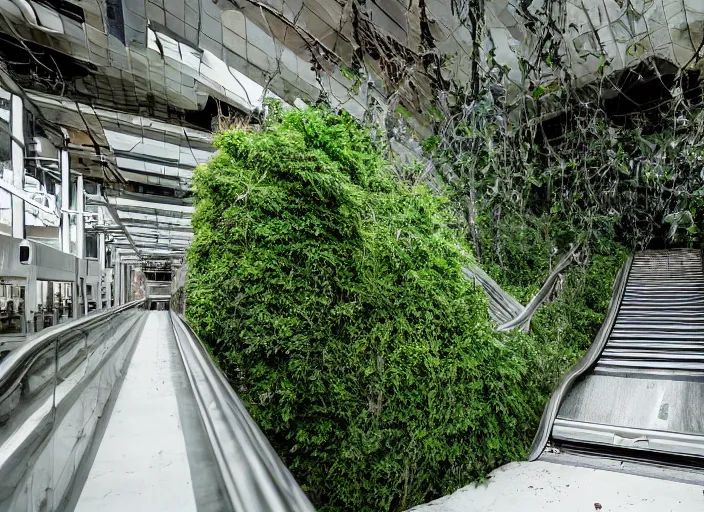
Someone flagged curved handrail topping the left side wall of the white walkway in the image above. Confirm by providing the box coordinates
[0,299,144,403]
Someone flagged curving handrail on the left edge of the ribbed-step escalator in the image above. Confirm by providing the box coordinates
[528,255,633,461]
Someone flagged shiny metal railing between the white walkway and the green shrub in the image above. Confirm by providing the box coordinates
[171,311,315,512]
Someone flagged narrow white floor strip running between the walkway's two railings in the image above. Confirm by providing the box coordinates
[75,311,196,512]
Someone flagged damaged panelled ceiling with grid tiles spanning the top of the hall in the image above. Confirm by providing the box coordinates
[0,0,704,258]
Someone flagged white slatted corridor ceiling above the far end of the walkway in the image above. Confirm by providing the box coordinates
[28,93,214,263]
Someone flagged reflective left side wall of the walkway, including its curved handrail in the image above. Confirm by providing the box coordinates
[0,301,143,511]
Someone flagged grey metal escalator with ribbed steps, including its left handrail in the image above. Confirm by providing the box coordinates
[530,249,704,468]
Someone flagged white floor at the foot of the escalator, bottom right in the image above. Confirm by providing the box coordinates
[409,461,704,512]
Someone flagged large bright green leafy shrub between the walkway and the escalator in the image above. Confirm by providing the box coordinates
[187,109,564,512]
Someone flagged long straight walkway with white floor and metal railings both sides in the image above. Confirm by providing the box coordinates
[0,300,313,512]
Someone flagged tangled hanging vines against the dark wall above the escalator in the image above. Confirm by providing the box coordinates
[426,1,704,284]
